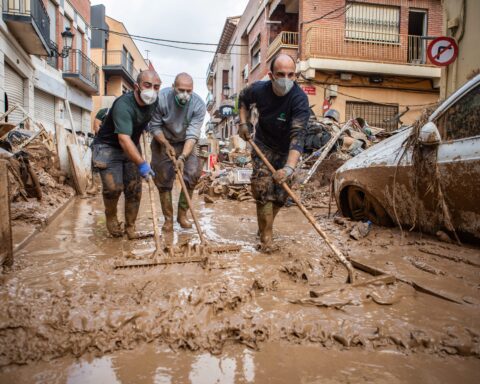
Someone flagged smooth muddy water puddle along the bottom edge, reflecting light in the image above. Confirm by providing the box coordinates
[0,343,480,384]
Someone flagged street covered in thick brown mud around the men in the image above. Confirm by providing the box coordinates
[0,186,480,383]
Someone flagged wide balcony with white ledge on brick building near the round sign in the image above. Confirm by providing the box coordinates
[304,27,440,77]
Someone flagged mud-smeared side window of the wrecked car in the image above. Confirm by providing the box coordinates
[436,85,480,140]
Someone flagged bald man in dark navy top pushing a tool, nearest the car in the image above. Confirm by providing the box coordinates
[238,54,310,252]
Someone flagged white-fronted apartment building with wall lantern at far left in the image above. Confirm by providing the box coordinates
[0,0,98,132]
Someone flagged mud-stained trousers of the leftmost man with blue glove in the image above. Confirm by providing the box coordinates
[93,144,142,236]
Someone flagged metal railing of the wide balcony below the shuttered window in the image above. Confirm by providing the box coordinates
[305,27,431,66]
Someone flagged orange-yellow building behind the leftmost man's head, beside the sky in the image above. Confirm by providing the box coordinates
[91,4,150,121]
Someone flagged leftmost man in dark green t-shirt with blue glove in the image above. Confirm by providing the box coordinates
[93,71,161,239]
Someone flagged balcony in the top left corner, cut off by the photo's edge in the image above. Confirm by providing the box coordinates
[3,0,50,56]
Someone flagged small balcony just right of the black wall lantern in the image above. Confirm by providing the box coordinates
[63,49,99,95]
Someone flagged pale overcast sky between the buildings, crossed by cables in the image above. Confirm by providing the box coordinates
[92,0,248,103]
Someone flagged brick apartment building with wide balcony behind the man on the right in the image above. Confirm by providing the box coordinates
[207,0,443,134]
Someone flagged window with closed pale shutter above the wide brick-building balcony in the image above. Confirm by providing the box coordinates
[345,2,400,43]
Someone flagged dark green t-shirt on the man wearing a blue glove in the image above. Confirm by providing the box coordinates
[97,92,156,148]
